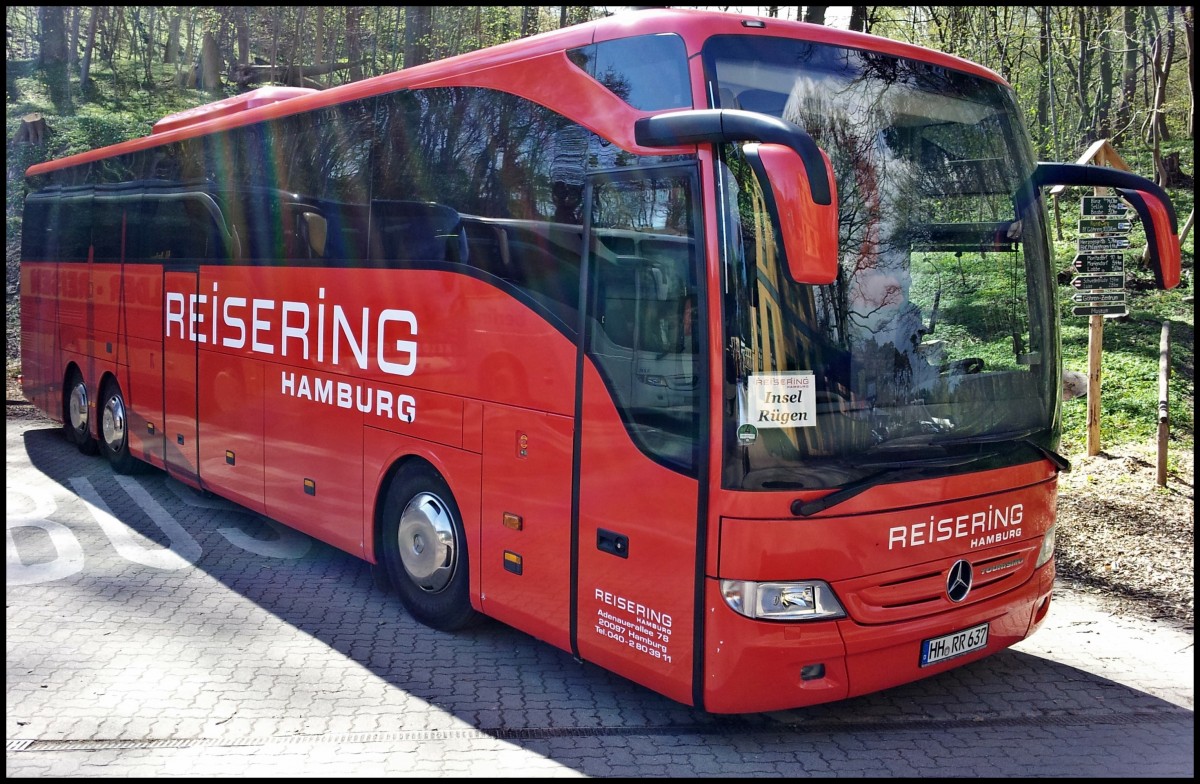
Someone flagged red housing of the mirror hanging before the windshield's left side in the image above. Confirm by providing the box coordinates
[743,144,838,285]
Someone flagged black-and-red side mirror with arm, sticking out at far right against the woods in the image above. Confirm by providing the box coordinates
[1033,163,1181,288]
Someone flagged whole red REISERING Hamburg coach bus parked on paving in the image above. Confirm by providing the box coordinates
[20,10,1180,713]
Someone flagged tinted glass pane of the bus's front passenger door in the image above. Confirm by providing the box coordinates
[586,169,703,472]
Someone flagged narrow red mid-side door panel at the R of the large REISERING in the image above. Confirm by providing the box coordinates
[162,269,203,487]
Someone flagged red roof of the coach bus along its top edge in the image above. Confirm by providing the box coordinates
[26,8,1007,176]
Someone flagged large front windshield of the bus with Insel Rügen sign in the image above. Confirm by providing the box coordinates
[704,36,1060,490]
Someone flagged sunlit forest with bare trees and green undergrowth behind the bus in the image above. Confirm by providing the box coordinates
[5,5,1195,623]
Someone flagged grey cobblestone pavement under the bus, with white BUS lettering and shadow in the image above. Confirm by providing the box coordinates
[5,420,1194,778]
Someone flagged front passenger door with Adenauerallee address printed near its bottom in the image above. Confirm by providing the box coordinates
[575,168,704,704]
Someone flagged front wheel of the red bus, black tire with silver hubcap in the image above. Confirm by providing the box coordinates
[382,463,478,632]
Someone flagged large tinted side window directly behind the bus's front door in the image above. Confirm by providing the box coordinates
[371,88,593,328]
